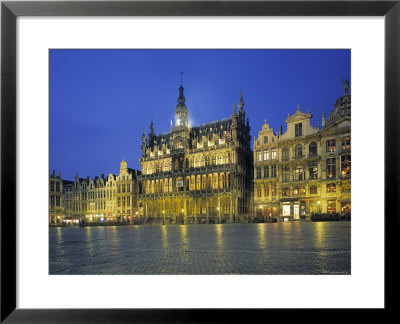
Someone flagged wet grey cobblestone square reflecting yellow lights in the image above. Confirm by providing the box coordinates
[49,221,351,275]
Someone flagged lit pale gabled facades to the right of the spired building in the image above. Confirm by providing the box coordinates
[254,80,351,220]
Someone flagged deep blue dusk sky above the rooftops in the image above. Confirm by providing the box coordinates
[50,50,351,180]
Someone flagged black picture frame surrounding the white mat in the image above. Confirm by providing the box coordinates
[0,0,400,323]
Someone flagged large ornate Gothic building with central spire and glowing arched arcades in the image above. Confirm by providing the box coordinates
[138,85,253,224]
